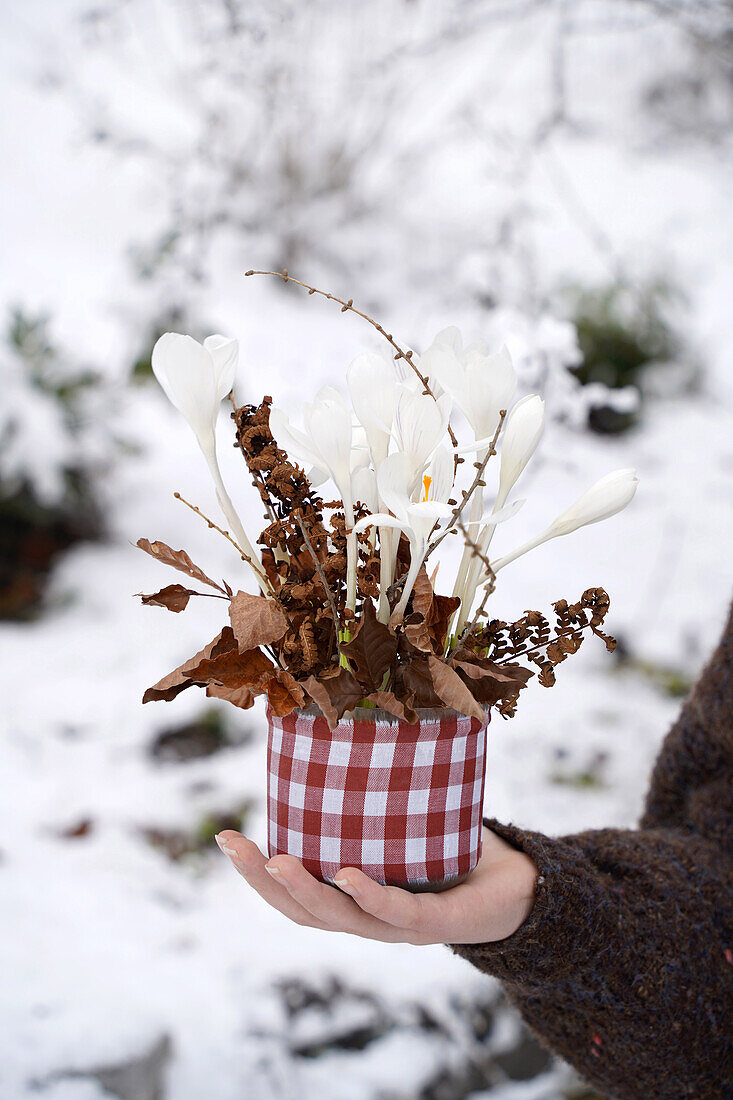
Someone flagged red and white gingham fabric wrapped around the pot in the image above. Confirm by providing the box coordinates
[267,711,486,889]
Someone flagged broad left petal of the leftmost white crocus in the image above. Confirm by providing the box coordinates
[152,332,219,447]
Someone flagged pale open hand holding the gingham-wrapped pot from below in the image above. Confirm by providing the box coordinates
[217,827,537,945]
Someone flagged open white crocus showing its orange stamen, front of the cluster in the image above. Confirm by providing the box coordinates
[355,448,453,618]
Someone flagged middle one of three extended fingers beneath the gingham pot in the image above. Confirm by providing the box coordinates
[267,856,428,943]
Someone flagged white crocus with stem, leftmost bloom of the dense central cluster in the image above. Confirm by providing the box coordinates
[270,386,363,611]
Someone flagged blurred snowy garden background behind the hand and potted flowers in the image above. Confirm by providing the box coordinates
[0,0,733,1100]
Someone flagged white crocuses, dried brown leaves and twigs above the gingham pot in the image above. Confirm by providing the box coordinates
[138,272,637,729]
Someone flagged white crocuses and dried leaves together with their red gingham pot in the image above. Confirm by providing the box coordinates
[138,272,636,890]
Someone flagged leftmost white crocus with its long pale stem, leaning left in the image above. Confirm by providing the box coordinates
[152,332,270,594]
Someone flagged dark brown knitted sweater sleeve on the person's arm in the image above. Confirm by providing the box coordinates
[453,608,733,1100]
